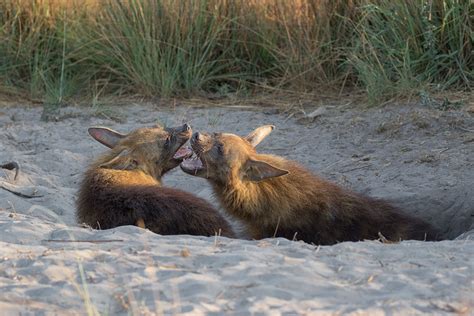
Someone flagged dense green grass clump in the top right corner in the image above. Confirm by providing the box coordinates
[349,0,474,103]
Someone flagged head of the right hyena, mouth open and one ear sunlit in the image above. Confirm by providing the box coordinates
[180,125,288,184]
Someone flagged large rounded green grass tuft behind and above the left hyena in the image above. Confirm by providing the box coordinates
[80,0,237,96]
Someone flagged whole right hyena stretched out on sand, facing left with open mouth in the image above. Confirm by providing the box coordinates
[181,125,437,244]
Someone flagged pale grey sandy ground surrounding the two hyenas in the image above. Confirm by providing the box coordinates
[0,104,474,315]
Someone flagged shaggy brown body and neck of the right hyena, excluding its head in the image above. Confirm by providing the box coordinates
[214,157,439,245]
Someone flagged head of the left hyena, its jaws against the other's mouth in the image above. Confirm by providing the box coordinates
[88,124,192,179]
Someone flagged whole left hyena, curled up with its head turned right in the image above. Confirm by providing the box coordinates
[77,124,234,237]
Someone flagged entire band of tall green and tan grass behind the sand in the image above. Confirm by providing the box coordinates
[0,0,474,113]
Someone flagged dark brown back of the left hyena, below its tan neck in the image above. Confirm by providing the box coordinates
[77,180,234,237]
